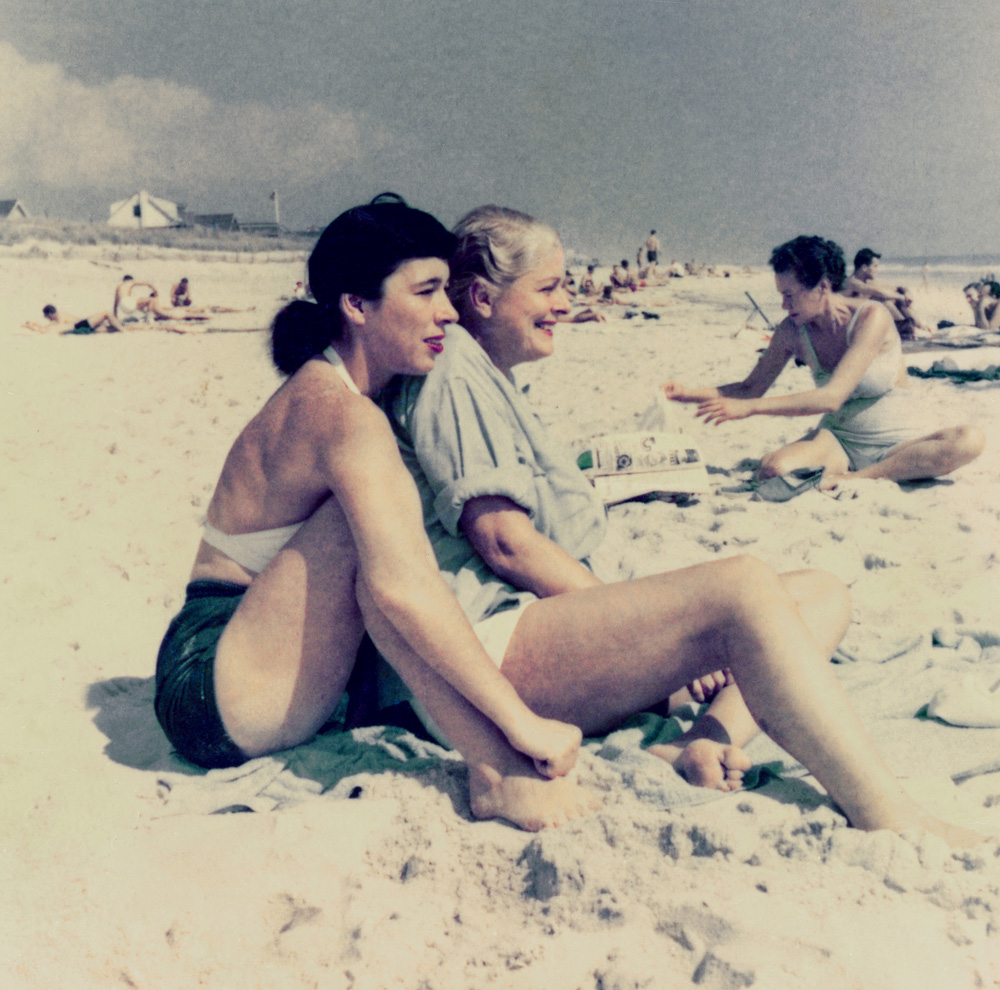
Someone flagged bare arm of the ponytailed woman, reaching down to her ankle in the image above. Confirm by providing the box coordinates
[322,397,579,776]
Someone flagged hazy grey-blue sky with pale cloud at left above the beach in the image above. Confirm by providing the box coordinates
[0,0,1000,261]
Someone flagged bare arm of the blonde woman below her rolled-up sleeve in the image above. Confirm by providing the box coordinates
[459,495,601,598]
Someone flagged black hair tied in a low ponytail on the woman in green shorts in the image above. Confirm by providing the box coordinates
[271,193,457,375]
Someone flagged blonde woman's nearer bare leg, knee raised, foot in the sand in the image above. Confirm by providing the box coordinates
[503,557,979,844]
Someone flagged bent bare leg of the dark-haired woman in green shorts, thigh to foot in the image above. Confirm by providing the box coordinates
[215,498,595,830]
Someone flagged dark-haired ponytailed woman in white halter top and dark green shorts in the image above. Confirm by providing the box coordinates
[155,195,594,829]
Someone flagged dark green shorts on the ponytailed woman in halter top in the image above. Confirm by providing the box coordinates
[154,581,248,767]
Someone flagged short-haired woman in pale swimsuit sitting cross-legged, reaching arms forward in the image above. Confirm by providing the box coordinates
[664,237,985,489]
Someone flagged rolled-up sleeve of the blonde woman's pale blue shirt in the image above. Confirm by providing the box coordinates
[413,378,538,536]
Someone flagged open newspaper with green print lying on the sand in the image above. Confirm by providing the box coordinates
[577,395,712,505]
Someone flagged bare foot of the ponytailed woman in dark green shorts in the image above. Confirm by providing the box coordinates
[469,754,600,832]
